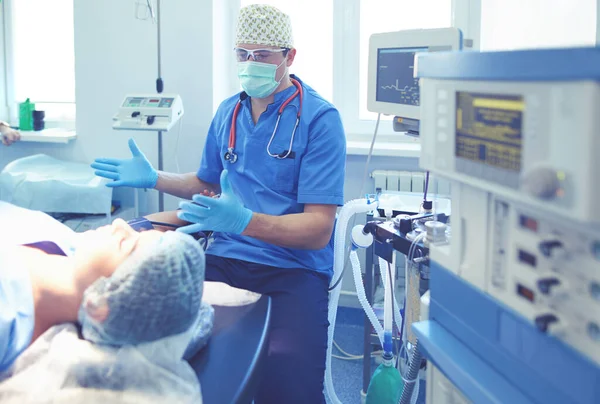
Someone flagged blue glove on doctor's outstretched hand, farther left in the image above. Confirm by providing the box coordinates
[92,139,158,188]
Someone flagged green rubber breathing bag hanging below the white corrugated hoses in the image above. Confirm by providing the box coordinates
[365,356,404,404]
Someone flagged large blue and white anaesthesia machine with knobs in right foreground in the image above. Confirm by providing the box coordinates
[413,48,600,404]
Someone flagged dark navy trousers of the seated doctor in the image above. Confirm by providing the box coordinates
[206,255,329,404]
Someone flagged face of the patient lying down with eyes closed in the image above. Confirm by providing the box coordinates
[74,219,162,277]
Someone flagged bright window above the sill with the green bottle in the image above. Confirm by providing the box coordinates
[4,0,75,121]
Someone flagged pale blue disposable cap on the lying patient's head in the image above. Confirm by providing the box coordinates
[78,232,205,346]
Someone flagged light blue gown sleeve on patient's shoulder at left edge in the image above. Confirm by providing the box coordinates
[0,249,34,372]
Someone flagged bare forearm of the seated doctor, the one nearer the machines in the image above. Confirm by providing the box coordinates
[242,204,337,250]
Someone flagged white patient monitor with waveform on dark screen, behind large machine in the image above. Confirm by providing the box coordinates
[367,28,463,136]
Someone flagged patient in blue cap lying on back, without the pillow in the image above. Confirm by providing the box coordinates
[0,203,212,372]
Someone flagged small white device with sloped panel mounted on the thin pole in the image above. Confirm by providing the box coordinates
[113,94,184,132]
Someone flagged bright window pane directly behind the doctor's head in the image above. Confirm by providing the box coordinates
[238,0,333,101]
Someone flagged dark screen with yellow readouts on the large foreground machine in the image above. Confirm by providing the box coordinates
[455,92,525,172]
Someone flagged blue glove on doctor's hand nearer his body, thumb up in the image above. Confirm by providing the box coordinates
[177,170,252,234]
